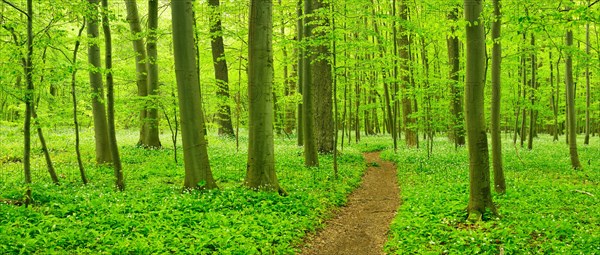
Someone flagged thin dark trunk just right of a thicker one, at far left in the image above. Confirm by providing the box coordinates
[102,0,125,191]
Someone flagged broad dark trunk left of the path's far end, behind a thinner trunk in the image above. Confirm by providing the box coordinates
[311,0,334,154]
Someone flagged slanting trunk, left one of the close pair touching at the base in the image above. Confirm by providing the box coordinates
[124,0,148,147]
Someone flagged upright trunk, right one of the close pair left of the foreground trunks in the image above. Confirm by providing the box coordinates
[143,0,162,148]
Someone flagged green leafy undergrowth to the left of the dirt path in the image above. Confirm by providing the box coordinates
[0,126,365,254]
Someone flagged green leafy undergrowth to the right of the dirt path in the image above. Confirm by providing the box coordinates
[382,136,600,254]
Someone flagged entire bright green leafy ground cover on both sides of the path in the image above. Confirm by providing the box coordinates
[0,126,600,254]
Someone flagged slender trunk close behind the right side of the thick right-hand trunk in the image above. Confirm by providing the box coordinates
[490,0,506,193]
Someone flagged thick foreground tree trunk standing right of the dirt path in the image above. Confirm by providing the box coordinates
[464,0,496,222]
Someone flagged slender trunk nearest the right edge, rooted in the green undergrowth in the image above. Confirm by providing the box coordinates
[565,25,581,169]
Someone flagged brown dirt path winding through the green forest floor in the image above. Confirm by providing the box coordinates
[300,152,400,255]
